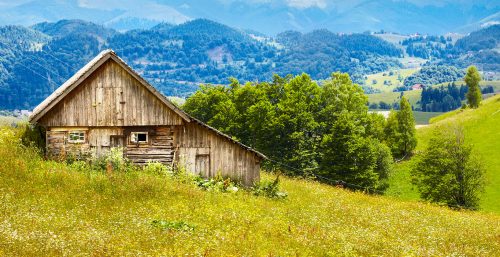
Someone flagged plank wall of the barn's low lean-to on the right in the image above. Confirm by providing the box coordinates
[177,122,260,186]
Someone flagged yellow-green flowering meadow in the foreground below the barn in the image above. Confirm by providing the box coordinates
[0,128,500,256]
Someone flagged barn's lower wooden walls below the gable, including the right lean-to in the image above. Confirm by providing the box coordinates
[47,122,260,186]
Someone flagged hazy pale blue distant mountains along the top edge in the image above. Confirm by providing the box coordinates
[0,0,500,35]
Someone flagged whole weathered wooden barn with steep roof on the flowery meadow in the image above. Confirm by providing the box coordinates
[30,50,265,185]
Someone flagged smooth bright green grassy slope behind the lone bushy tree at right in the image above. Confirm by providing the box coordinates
[388,95,500,213]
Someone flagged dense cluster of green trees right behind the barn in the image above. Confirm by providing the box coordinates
[183,73,416,190]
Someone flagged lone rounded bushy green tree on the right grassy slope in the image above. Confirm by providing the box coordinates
[412,126,484,209]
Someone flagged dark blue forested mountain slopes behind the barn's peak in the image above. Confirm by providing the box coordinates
[0,19,401,109]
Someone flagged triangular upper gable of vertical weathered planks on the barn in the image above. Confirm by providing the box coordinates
[39,59,182,127]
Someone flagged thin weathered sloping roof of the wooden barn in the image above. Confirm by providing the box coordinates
[29,49,266,158]
